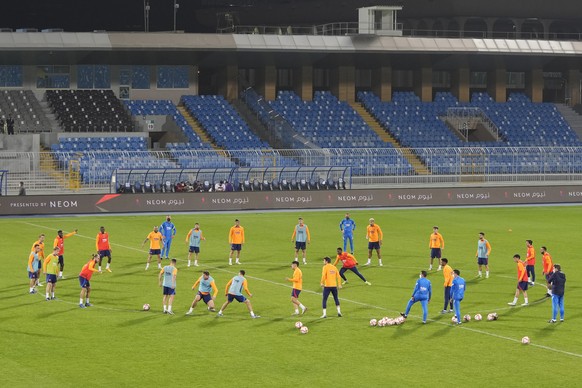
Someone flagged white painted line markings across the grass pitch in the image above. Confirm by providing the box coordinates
[22,222,582,358]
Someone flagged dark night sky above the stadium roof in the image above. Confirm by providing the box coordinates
[0,0,582,32]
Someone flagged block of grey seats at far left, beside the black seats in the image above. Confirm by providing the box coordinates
[0,90,51,133]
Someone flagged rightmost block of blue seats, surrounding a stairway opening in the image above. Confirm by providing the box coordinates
[358,92,582,174]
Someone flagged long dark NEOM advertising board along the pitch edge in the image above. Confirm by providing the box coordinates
[0,185,582,216]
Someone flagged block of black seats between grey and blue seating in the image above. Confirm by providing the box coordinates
[46,89,134,132]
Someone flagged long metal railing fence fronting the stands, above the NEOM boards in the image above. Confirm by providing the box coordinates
[0,147,582,195]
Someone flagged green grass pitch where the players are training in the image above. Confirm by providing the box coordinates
[0,206,582,387]
